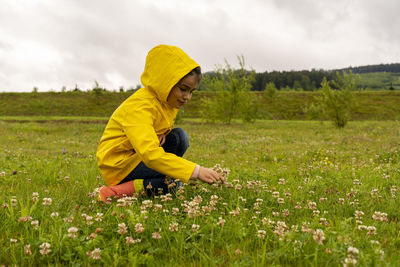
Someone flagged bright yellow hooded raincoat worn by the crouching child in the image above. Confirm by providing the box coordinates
[96,45,199,186]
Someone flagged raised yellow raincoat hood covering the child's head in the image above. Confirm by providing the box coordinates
[141,45,199,102]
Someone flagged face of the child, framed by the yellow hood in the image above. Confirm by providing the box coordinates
[167,74,199,108]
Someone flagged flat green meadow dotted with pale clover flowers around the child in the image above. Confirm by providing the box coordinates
[0,118,400,266]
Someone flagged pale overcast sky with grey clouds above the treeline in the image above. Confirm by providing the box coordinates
[0,0,400,92]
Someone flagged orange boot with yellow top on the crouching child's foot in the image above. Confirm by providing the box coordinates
[99,179,143,202]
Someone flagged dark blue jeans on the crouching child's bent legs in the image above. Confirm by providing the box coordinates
[120,128,189,195]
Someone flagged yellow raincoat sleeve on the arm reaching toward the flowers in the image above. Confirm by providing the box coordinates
[121,104,196,182]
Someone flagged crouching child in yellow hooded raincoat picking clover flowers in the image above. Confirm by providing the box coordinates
[96,45,223,202]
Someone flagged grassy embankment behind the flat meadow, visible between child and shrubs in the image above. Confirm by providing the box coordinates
[0,91,400,120]
